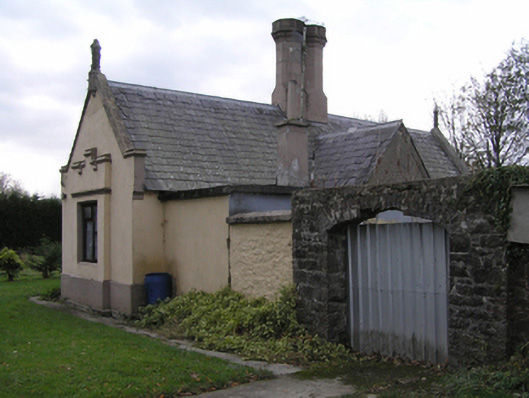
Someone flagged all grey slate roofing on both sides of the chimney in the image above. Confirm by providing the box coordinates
[108,81,464,192]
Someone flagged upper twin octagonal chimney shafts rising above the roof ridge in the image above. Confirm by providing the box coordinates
[272,19,327,123]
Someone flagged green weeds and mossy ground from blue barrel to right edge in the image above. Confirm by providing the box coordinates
[137,286,529,398]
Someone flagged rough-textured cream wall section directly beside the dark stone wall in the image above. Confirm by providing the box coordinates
[230,222,293,299]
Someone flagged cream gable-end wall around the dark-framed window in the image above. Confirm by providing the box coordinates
[62,93,134,282]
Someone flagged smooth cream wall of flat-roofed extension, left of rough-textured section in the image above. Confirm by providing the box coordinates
[165,196,229,294]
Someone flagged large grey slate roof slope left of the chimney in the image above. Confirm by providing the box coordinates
[109,82,282,191]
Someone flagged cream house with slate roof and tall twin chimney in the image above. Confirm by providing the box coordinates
[61,19,466,313]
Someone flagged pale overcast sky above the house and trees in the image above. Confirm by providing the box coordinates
[0,0,529,196]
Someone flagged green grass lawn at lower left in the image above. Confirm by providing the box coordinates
[0,276,266,398]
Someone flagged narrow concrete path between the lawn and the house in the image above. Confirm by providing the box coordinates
[30,297,355,398]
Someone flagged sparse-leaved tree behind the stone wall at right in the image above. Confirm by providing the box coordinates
[438,40,529,169]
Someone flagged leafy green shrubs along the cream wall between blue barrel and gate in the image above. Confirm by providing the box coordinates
[138,287,346,364]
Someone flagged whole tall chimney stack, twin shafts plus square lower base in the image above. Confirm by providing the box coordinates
[272,19,327,187]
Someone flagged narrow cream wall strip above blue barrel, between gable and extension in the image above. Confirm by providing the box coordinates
[132,193,165,284]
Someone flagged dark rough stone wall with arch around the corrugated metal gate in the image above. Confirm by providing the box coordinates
[292,177,509,364]
